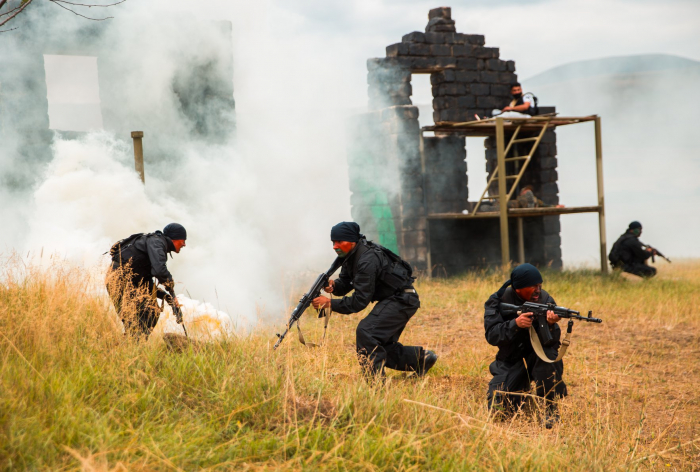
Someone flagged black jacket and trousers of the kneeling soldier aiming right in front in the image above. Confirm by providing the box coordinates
[484,287,567,411]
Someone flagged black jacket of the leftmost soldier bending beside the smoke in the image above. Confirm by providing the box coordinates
[112,231,175,297]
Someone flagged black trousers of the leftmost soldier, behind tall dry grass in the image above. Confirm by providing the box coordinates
[106,271,160,339]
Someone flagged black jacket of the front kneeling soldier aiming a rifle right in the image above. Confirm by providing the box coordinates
[484,287,561,362]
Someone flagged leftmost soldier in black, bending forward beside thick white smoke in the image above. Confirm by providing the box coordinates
[107,223,187,339]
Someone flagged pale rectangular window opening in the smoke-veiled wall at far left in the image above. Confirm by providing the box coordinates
[44,55,103,131]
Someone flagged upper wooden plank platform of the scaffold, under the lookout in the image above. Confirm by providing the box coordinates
[422,115,597,137]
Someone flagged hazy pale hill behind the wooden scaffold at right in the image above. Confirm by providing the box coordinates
[523,54,700,263]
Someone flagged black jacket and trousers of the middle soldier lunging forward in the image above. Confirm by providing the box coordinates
[331,238,426,375]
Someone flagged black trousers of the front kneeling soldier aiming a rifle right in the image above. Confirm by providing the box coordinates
[486,349,567,413]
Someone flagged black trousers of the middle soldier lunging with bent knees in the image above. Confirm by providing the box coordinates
[356,293,425,376]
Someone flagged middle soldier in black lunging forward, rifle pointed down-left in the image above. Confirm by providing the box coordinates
[312,222,437,376]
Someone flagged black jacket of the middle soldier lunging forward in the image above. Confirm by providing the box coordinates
[331,239,411,315]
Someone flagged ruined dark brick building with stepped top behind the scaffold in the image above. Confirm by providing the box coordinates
[348,7,562,274]
